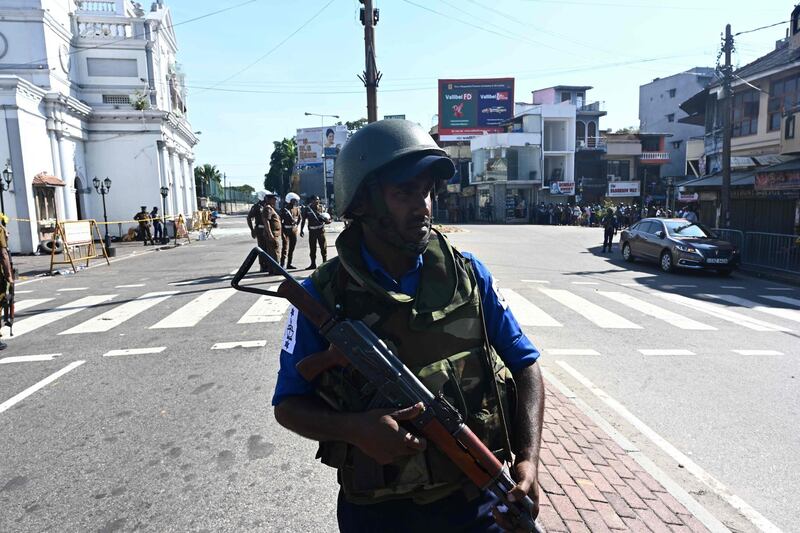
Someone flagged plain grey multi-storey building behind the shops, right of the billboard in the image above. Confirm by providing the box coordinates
[639,67,714,177]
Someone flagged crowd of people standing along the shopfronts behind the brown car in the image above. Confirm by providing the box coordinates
[531,202,697,228]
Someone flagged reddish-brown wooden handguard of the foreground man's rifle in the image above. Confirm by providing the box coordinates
[419,418,503,489]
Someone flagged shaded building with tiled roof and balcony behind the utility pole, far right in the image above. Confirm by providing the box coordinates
[680,6,800,233]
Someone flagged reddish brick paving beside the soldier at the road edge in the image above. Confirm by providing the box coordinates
[539,387,708,533]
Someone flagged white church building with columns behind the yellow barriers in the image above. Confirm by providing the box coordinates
[0,0,198,253]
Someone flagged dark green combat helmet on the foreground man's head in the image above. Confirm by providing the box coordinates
[333,119,455,216]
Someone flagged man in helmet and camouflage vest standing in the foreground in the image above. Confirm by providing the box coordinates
[272,120,544,532]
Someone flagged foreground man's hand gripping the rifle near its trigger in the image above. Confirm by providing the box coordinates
[352,403,427,465]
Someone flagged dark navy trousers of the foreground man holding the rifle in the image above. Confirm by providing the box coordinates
[336,491,503,533]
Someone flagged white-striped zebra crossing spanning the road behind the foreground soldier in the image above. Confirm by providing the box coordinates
[7,284,800,337]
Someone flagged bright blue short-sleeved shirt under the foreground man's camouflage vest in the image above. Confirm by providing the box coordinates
[272,244,539,405]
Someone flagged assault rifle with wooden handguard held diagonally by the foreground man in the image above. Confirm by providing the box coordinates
[231,247,542,532]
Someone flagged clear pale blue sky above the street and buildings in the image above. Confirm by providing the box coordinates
[165,0,794,189]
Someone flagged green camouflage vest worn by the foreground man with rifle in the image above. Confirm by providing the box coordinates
[312,225,514,504]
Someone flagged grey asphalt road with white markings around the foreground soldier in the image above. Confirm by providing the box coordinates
[0,219,800,532]
